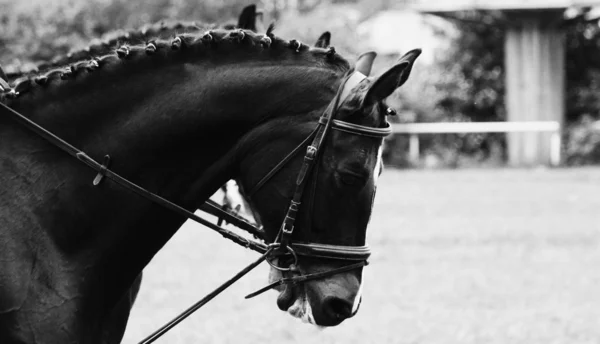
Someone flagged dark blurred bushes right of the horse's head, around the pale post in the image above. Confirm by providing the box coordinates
[390,9,600,166]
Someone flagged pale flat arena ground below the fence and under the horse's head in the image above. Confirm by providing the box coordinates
[124,168,600,344]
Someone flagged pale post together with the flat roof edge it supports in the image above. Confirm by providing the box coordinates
[409,0,600,165]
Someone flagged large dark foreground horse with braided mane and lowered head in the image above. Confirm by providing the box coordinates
[0,27,420,343]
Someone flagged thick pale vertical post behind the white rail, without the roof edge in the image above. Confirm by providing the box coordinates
[505,9,565,166]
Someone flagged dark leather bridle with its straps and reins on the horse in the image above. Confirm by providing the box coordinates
[0,71,391,344]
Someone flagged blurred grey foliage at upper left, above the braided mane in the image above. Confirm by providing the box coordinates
[0,0,268,70]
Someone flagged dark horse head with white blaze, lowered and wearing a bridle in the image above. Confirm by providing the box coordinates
[237,50,420,326]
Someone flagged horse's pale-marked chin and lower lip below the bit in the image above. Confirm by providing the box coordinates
[269,268,321,328]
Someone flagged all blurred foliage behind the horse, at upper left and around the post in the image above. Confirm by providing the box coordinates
[0,0,600,167]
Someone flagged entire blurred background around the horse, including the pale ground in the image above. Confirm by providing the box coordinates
[0,0,600,344]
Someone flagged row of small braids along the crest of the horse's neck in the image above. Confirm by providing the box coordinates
[0,26,349,101]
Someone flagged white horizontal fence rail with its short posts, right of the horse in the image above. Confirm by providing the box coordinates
[392,121,564,166]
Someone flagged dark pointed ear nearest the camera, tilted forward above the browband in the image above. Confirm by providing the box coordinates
[365,49,421,104]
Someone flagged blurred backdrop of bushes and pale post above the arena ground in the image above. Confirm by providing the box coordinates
[0,0,600,168]
